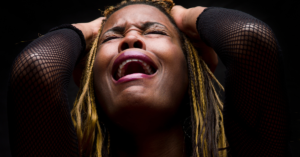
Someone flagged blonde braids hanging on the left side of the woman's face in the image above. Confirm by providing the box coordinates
[71,21,104,157]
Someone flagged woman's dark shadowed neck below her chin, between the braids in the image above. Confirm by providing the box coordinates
[110,124,186,157]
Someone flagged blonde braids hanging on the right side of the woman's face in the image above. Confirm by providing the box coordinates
[184,34,227,157]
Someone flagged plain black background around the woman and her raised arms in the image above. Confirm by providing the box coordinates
[0,0,300,157]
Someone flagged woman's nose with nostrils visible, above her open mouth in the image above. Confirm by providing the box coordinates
[118,34,146,52]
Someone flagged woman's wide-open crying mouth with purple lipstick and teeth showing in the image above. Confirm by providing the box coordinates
[112,53,157,81]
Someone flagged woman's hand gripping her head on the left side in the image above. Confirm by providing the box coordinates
[72,17,105,51]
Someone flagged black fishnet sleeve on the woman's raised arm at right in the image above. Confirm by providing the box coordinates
[197,7,288,157]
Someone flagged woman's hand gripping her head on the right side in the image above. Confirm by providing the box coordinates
[171,5,218,72]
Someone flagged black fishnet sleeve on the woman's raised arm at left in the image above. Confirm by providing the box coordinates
[8,26,85,156]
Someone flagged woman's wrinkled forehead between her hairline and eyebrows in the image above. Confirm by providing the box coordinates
[103,4,174,31]
